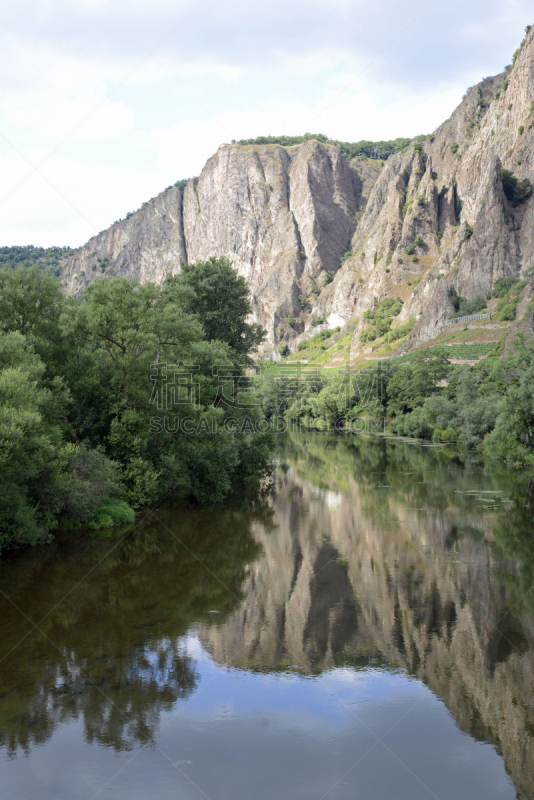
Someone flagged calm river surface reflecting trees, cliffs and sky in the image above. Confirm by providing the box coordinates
[0,435,534,800]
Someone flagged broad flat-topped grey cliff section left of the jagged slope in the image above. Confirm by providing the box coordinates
[64,140,364,344]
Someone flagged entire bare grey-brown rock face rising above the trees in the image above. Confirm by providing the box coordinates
[60,28,534,352]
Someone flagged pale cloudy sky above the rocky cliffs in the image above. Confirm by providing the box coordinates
[0,0,534,247]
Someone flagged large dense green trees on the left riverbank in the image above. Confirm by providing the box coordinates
[0,259,270,548]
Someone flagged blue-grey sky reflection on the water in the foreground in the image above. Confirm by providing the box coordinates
[0,636,515,800]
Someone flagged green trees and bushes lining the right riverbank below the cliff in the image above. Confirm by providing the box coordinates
[260,335,534,467]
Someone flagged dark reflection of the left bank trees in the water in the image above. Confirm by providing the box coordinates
[0,494,270,752]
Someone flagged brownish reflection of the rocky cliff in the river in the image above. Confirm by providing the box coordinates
[203,440,534,797]
